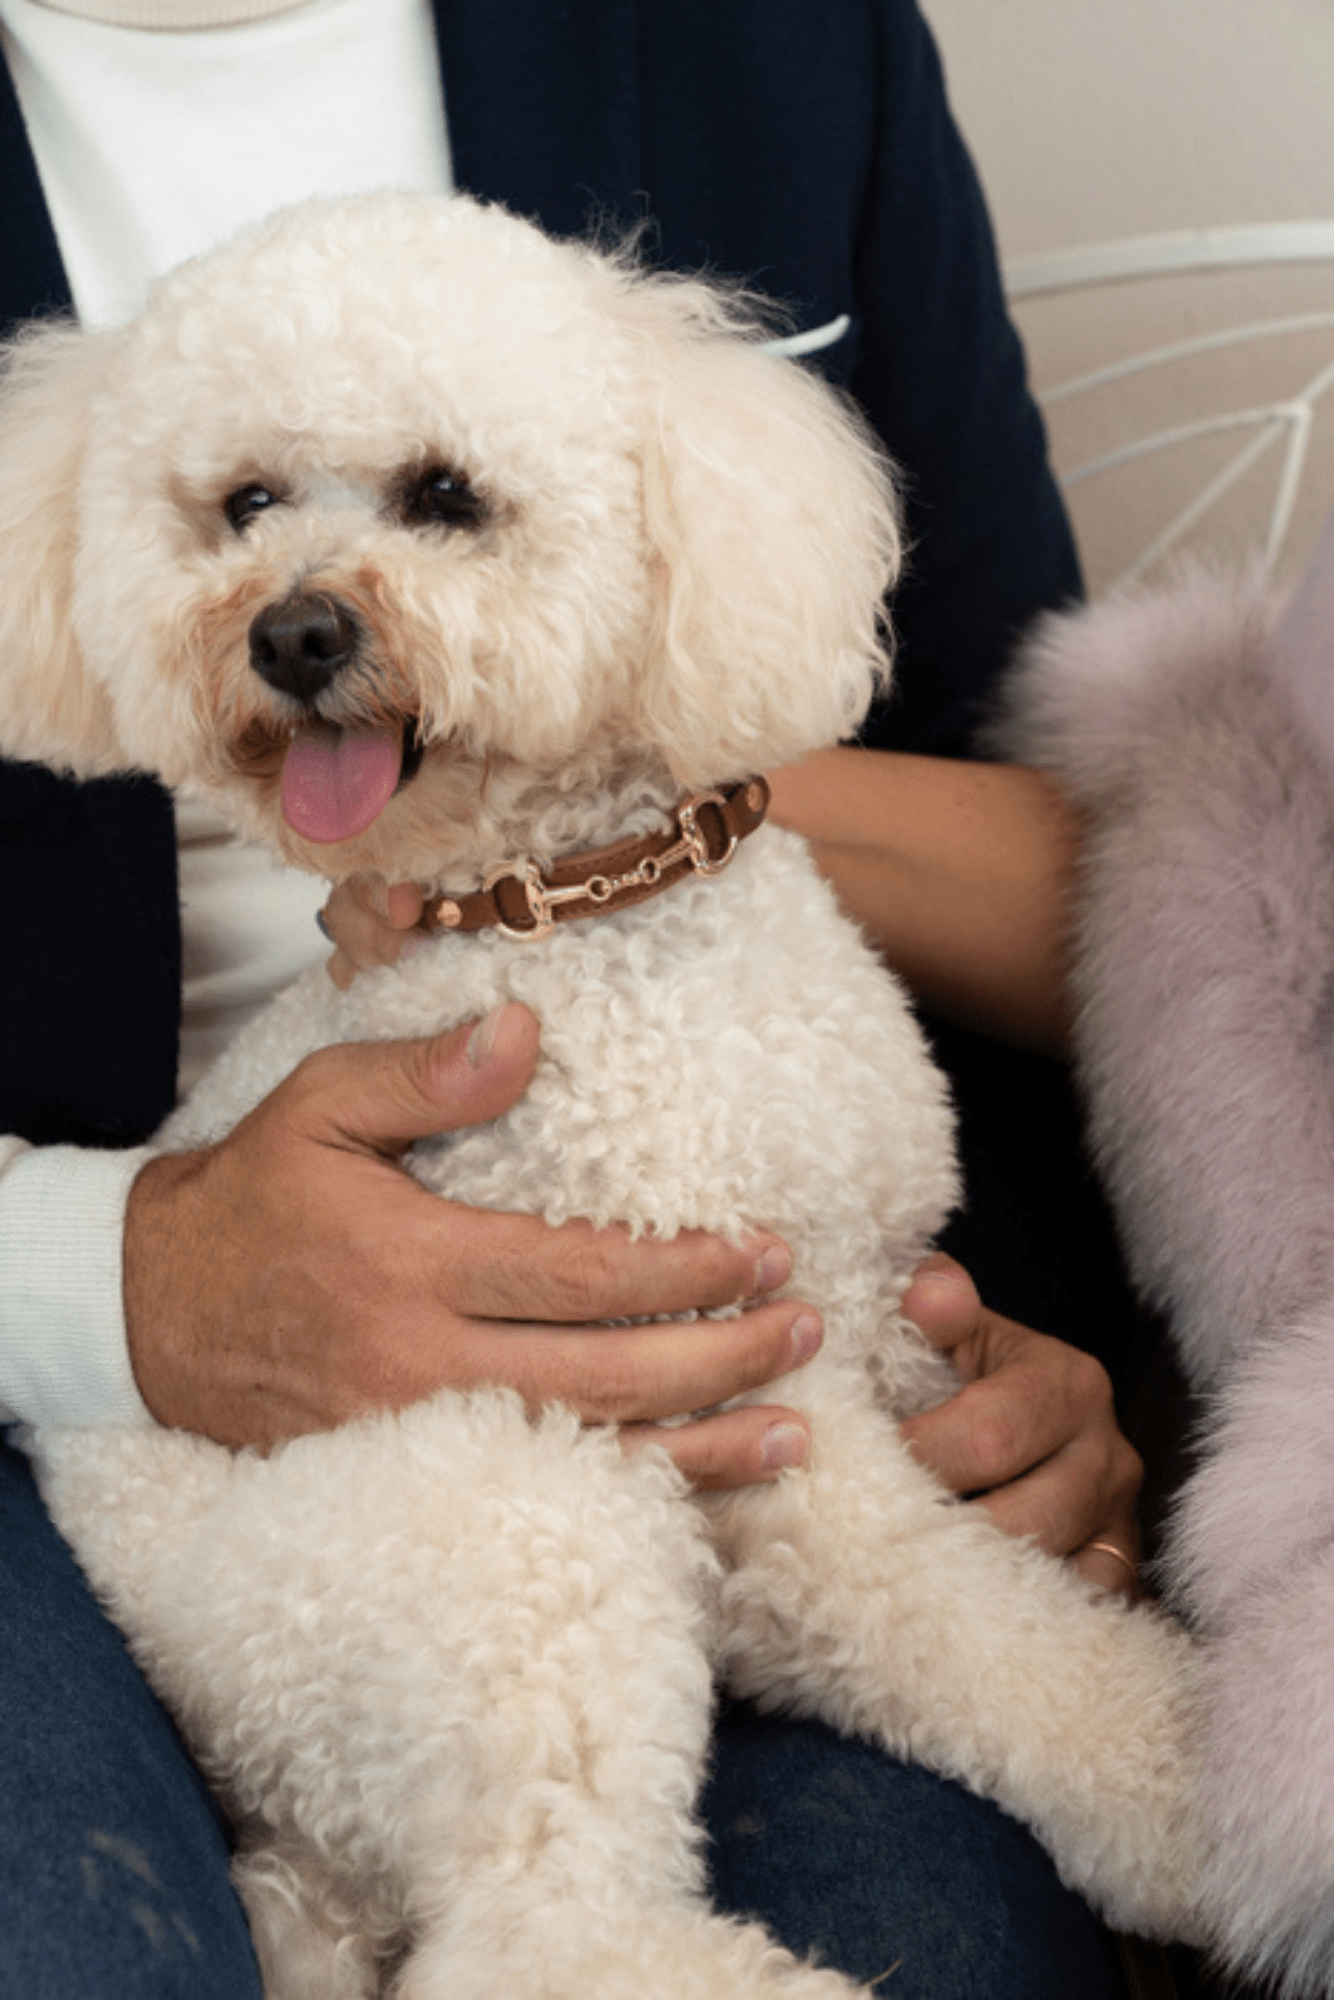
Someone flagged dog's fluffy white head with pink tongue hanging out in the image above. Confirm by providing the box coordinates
[0,196,898,876]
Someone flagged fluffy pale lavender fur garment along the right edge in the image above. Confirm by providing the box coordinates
[1000,568,1334,1996]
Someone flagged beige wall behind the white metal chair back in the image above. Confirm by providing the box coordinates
[924,0,1334,582]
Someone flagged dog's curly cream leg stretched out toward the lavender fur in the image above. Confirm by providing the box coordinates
[712,1384,1200,1936]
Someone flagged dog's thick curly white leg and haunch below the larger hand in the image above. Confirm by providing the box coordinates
[36,1394,872,2000]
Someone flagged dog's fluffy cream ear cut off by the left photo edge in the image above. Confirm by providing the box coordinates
[0,324,128,778]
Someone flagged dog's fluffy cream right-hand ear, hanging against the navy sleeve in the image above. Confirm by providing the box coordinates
[628,278,900,784]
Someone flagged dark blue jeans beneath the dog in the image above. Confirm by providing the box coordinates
[0,1446,1124,2000]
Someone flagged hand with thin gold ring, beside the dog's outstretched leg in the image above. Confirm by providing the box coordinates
[902,1252,1144,1594]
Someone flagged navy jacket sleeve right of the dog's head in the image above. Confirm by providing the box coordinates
[852,0,1080,752]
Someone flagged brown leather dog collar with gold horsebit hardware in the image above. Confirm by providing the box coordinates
[422,778,768,942]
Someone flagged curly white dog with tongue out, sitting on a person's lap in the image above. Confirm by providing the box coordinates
[0,196,1198,2000]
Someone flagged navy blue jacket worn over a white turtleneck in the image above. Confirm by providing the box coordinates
[0,0,1128,1360]
